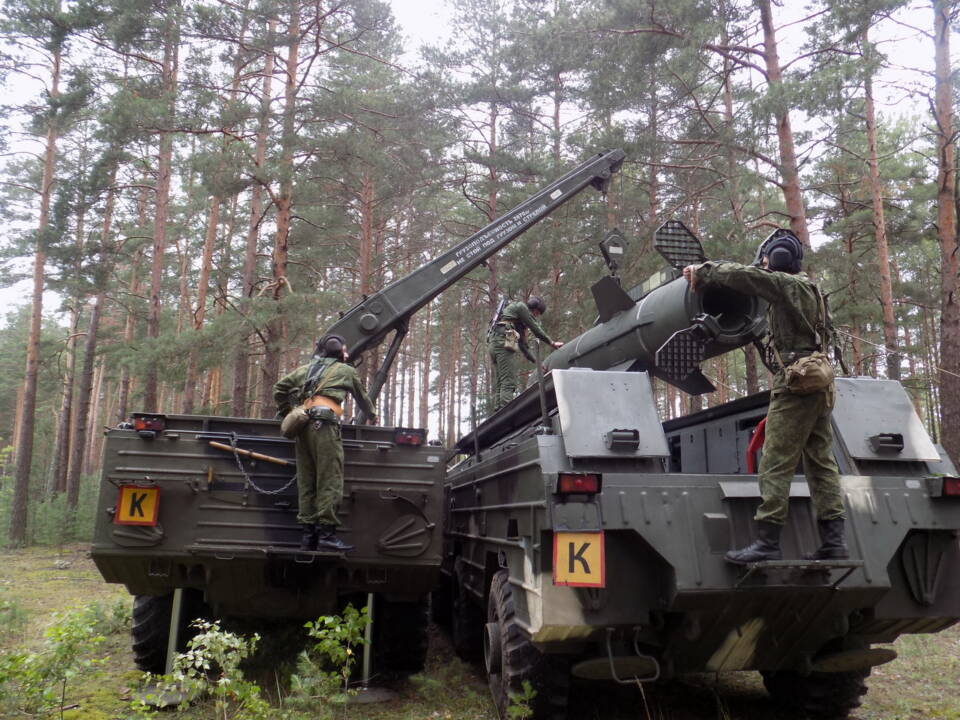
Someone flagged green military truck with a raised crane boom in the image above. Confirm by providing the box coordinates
[92,150,624,672]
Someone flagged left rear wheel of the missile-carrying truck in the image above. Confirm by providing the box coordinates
[483,570,570,720]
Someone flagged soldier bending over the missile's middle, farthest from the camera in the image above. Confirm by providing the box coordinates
[488,295,563,411]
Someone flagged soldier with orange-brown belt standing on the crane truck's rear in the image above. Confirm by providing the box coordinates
[273,335,377,552]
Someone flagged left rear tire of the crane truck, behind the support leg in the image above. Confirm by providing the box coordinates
[130,590,203,675]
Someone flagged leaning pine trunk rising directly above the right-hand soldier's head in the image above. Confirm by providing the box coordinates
[757,0,811,250]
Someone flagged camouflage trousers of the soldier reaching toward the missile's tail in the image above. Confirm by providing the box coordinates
[755,387,844,525]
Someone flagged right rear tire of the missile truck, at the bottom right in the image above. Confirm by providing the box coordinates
[761,670,870,720]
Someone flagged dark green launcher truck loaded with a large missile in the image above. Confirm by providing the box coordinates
[435,225,960,718]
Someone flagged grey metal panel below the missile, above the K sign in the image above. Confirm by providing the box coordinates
[553,368,669,457]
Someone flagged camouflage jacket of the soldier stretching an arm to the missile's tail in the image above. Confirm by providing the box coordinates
[696,262,826,364]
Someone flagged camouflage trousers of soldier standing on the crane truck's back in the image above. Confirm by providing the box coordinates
[296,420,343,525]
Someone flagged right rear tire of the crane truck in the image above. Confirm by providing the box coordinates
[373,595,429,673]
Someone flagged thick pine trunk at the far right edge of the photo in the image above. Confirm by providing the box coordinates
[932,0,960,462]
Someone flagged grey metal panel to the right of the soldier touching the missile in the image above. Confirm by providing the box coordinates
[833,377,940,461]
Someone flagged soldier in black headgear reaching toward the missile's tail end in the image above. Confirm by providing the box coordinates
[683,230,849,565]
